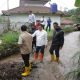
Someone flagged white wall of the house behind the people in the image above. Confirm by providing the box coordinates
[9,14,60,28]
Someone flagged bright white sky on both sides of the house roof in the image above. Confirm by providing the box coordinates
[0,0,75,13]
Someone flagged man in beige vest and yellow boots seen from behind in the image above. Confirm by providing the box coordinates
[18,25,32,76]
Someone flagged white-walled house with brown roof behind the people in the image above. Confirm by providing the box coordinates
[2,0,64,30]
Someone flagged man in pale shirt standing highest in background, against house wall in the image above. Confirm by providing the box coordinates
[28,11,36,32]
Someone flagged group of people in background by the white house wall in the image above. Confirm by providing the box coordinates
[28,11,52,31]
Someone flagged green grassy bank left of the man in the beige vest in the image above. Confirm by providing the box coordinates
[0,31,19,59]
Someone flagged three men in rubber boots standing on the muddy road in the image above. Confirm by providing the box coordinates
[18,10,64,76]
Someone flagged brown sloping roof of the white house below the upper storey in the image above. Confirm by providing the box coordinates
[2,6,64,15]
